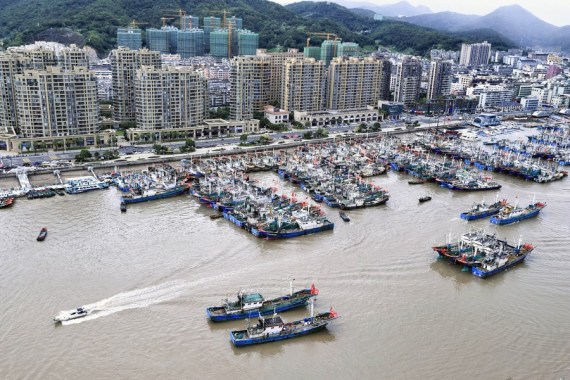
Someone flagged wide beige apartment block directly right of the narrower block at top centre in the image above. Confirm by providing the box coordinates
[326,57,386,110]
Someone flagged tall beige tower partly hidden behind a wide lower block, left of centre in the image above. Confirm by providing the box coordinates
[110,48,162,123]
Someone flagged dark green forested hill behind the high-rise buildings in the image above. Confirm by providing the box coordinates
[0,0,512,55]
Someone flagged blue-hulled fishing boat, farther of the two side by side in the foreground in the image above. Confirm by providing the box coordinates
[206,281,319,322]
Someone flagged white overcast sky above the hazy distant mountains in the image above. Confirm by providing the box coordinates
[273,0,570,26]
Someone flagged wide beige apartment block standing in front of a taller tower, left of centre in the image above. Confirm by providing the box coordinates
[135,66,209,130]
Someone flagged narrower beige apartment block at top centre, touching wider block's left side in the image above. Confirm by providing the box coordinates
[281,58,326,111]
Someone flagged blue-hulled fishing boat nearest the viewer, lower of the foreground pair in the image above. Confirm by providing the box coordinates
[230,302,339,347]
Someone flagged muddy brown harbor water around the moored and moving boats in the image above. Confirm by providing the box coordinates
[0,163,570,380]
